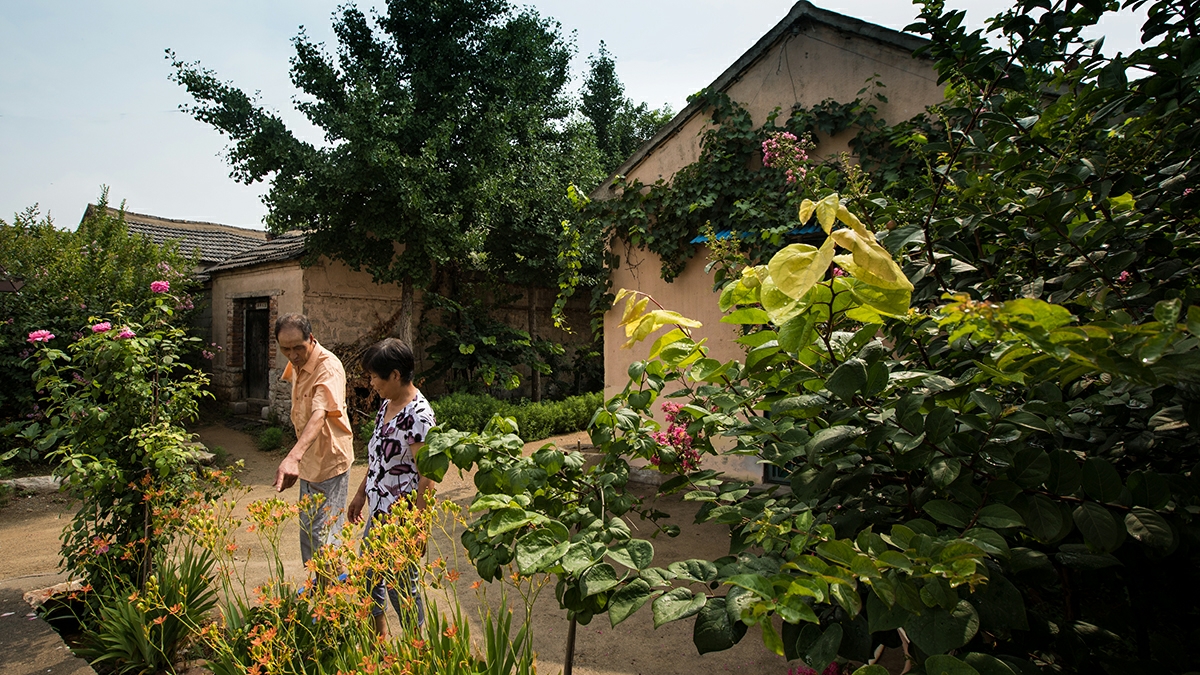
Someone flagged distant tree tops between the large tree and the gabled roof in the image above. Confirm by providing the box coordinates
[580,42,674,174]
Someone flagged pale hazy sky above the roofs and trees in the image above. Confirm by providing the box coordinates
[0,0,1140,228]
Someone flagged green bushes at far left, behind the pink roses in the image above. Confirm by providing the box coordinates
[0,190,194,451]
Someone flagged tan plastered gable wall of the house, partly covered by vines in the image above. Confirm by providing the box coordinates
[605,24,942,480]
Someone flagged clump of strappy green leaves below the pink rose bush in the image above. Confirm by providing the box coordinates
[77,549,217,674]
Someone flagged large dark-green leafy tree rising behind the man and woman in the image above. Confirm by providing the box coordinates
[168,0,587,340]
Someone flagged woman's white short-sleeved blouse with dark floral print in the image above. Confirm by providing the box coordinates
[367,392,437,518]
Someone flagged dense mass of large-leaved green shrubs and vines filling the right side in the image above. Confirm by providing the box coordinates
[425,1,1200,653]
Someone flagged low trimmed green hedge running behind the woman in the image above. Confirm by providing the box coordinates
[432,393,604,441]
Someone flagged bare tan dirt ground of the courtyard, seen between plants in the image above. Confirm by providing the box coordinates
[0,426,787,675]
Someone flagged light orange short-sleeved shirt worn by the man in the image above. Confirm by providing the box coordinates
[283,345,354,483]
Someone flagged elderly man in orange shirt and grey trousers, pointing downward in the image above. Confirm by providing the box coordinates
[275,313,354,563]
